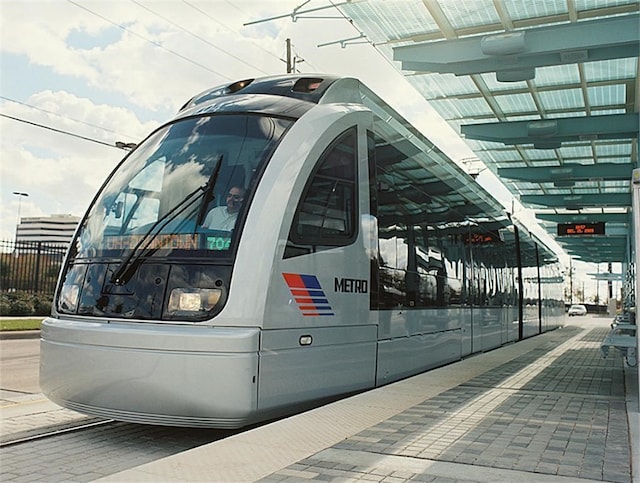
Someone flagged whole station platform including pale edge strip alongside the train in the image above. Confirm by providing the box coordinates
[95,316,640,482]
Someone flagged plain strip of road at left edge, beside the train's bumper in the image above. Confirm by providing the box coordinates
[0,338,40,394]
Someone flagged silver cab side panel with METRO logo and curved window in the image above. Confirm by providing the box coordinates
[258,113,376,410]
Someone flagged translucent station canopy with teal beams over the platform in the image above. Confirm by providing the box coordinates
[336,0,640,263]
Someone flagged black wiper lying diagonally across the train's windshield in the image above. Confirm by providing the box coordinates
[110,156,222,285]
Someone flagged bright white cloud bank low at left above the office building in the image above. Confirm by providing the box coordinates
[0,91,158,239]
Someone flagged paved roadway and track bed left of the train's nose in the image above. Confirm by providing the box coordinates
[0,337,242,483]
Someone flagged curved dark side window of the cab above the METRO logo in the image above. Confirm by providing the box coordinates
[284,128,357,258]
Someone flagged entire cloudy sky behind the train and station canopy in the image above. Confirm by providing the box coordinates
[0,0,603,300]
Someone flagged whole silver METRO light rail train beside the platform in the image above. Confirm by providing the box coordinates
[40,75,564,428]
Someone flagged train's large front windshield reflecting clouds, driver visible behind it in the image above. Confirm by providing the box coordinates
[72,114,292,262]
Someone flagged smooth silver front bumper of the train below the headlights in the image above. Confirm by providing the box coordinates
[40,318,260,428]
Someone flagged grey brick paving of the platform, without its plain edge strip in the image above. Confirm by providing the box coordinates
[261,327,631,482]
